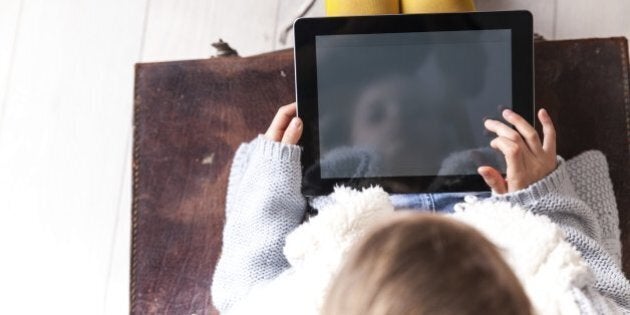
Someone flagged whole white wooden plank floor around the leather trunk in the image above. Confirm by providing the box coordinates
[0,0,630,314]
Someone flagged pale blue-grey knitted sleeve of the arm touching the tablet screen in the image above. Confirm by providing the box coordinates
[491,154,630,310]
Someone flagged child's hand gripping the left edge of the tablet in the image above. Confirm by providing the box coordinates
[265,103,302,144]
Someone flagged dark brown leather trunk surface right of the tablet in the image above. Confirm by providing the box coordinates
[535,38,630,275]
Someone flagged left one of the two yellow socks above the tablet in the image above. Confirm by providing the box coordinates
[326,0,400,16]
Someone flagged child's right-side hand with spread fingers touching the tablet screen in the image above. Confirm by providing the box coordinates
[477,109,557,194]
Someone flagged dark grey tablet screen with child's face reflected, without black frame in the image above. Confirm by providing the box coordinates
[316,30,512,178]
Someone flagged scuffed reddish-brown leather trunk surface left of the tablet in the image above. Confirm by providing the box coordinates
[131,51,295,315]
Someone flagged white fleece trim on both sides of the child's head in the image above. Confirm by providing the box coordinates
[231,187,594,315]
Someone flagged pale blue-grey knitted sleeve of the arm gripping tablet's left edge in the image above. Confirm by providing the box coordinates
[211,135,306,313]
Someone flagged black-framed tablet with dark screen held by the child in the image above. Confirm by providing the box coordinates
[295,11,534,196]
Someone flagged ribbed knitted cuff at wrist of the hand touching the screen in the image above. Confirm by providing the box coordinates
[490,156,572,205]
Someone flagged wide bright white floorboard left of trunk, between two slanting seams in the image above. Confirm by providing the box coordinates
[0,0,145,314]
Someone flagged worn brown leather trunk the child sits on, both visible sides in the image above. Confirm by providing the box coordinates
[131,38,630,314]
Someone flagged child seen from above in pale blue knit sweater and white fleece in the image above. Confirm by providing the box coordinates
[212,104,630,314]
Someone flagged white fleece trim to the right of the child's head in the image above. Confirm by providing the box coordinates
[452,196,594,314]
